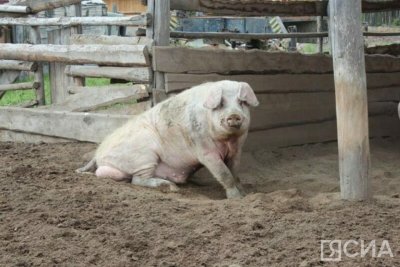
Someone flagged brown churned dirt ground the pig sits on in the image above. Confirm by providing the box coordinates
[0,138,400,267]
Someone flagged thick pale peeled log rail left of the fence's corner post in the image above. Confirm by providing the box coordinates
[0,44,148,66]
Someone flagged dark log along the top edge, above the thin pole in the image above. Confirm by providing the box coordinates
[171,0,400,16]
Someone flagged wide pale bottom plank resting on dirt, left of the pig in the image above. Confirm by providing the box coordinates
[0,107,132,142]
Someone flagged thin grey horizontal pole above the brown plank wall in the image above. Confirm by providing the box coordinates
[170,31,328,40]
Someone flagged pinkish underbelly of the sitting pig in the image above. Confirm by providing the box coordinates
[155,162,200,184]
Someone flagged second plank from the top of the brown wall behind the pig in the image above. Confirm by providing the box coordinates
[165,72,400,93]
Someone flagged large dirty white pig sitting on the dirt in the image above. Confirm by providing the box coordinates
[77,80,259,198]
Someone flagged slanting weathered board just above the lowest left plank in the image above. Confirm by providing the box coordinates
[48,85,149,112]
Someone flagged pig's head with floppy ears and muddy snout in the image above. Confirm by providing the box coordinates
[203,81,258,138]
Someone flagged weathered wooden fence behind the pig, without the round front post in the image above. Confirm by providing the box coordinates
[0,0,400,149]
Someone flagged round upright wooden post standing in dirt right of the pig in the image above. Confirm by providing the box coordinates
[329,0,371,200]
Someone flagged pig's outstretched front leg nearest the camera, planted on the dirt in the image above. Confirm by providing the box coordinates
[200,153,244,198]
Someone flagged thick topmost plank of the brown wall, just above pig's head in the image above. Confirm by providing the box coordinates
[153,46,400,74]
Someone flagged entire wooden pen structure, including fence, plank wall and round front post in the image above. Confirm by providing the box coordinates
[0,0,400,200]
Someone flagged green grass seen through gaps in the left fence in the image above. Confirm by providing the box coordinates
[0,75,110,106]
